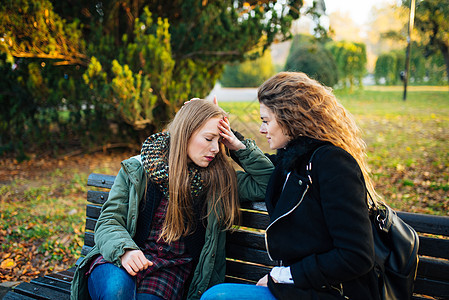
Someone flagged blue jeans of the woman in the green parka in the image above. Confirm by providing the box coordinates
[87,263,161,300]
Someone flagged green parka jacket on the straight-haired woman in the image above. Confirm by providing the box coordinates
[70,140,274,300]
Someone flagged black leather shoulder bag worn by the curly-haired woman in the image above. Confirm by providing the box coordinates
[306,146,419,300]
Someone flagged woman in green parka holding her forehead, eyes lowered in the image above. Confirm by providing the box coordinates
[71,100,273,299]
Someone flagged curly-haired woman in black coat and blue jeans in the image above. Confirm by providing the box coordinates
[202,72,379,300]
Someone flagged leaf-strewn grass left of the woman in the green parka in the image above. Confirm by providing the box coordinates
[0,151,135,282]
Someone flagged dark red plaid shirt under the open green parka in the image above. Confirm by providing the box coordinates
[87,197,192,299]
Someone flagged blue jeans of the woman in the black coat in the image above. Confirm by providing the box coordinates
[201,283,276,300]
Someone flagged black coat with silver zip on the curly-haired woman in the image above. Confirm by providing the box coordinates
[265,137,378,300]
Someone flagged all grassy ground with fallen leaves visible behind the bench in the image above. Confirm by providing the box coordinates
[0,89,449,282]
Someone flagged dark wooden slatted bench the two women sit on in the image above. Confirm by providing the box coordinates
[3,173,449,300]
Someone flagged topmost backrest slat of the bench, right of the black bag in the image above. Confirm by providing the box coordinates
[397,211,449,236]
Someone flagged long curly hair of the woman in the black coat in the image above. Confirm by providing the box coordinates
[258,72,380,202]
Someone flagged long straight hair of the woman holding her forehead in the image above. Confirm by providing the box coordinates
[160,99,239,243]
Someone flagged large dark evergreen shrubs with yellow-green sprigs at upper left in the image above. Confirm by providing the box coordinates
[0,0,303,157]
